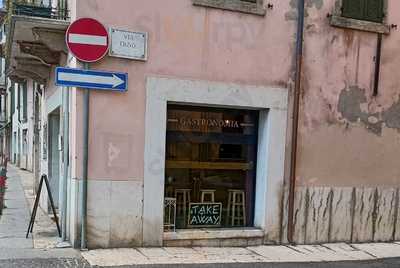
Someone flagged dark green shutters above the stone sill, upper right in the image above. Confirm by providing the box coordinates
[342,0,384,23]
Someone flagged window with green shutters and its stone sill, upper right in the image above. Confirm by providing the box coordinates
[330,0,390,34]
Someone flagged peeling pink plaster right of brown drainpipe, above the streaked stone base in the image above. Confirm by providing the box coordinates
[297,0,400,187]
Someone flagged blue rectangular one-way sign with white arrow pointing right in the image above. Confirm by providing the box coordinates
[56,67,128,92]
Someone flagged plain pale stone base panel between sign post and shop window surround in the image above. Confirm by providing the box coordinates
[87,180,143,249]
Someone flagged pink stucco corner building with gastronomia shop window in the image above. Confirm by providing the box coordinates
[5,0,400,248]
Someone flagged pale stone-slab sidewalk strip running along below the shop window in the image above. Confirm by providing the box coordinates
[82,243,400,267]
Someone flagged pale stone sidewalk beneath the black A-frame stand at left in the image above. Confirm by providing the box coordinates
[0,165,80,260]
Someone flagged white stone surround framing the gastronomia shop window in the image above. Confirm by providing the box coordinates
[143,77,288,246]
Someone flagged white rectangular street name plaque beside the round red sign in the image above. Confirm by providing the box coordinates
[109,28,148,61]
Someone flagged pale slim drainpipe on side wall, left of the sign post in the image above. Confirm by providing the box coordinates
[61,87,69,241]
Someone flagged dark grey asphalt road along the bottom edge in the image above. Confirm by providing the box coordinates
[0,258,400,268]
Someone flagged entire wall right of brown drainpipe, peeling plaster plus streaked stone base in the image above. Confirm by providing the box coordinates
[281,0,400,244]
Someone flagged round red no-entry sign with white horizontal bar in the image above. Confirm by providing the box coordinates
[66,18,110,62]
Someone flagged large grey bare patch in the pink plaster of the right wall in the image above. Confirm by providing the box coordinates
[338,86,400,136]
